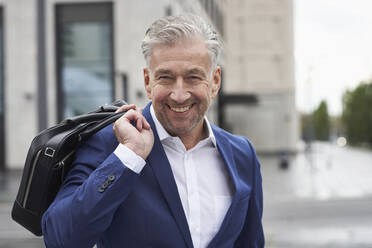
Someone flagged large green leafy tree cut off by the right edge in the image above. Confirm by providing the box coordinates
[342,80,372,146]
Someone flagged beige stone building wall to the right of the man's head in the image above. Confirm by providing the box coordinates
[223,0,298,153]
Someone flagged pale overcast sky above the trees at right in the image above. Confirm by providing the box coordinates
[294,0,372,115]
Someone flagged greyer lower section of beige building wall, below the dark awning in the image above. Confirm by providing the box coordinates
[226,93,298,154]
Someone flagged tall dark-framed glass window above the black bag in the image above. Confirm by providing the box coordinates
[57,3,114,120]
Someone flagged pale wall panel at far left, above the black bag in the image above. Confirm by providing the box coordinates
[0,0,38,168]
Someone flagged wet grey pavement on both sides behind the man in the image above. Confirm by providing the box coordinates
[0,140,372,248]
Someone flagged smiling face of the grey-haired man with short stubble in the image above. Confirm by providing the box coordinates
[144,39,221,139]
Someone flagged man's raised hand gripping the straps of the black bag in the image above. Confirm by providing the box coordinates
[113,108,154,160]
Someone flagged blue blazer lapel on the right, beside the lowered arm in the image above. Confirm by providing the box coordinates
[208,126,246,247]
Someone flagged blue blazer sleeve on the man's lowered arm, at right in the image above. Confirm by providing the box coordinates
[235,140,265,248]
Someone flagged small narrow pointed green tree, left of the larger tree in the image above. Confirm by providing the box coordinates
[312,101,330,141]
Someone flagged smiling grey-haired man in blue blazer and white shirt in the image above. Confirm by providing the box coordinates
[42,15,264,248]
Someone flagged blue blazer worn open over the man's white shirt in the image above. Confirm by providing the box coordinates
[42,103,264,248]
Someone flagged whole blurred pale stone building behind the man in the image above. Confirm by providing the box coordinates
[0,0,296,169]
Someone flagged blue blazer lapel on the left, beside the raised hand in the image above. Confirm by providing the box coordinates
[142,103,193,247]
